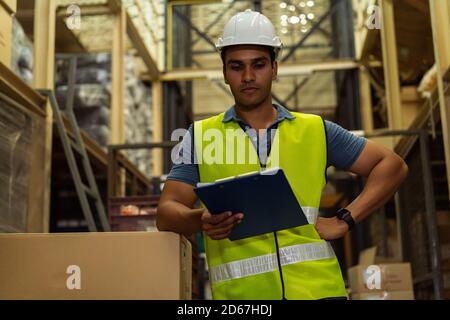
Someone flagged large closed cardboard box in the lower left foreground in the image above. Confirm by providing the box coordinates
[0,232,192,300]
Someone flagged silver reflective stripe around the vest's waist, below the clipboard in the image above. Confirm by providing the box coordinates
[209,242,335,284]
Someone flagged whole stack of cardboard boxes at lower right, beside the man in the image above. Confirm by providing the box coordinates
[348,247,414,300]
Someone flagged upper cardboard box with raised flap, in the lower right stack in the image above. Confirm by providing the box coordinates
[348,247,413,293]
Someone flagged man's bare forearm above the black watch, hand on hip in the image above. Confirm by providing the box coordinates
[347,156,408,222]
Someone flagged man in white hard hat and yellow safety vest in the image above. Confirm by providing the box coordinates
[157,10,408,299]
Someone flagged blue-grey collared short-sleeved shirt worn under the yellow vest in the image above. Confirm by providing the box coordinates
[167,105,367,186]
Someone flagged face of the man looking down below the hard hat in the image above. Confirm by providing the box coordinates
[224,45,277,109]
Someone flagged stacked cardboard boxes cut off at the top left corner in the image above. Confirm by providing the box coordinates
[0,0,17,68]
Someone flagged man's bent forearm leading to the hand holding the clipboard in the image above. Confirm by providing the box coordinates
[156,200,203,235]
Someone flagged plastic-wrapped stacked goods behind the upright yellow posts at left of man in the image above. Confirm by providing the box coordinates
[56,53,152,178]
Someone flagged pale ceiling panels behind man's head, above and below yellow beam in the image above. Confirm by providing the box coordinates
[173,0,337,119]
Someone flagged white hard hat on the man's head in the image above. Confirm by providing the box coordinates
[216,9,283,57]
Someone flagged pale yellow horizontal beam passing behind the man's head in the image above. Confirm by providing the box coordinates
[161,60,359,81]
